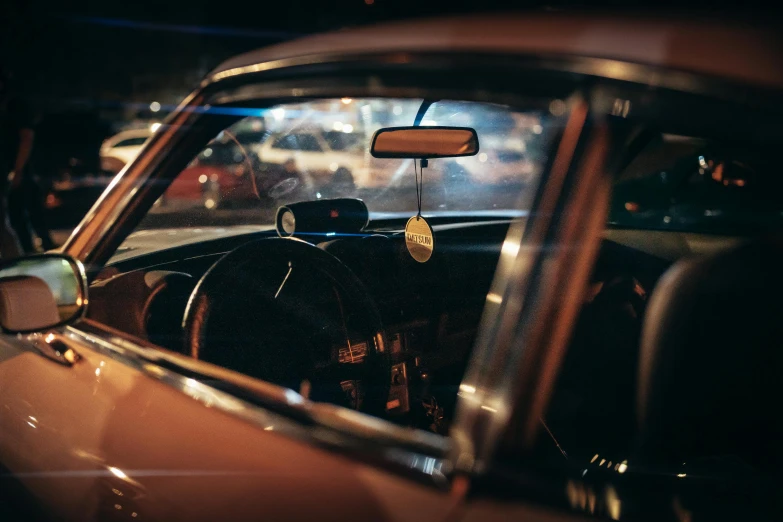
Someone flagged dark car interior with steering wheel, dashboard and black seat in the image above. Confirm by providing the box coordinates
[82,90,783,488]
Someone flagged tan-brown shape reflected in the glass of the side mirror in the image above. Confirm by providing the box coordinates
[0,276,60,331]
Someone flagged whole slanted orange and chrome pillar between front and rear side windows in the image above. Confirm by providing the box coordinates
[452,95,610,474]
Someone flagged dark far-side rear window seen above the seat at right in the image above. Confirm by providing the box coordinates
[609,135,783,235]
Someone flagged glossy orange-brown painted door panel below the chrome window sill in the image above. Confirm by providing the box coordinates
[0,325,462,521]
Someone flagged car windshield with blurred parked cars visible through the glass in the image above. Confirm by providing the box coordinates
[124,98,565,248]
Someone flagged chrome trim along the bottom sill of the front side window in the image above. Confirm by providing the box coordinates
[60,325,453,489]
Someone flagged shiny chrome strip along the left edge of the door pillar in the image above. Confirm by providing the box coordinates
[453,96,587,473]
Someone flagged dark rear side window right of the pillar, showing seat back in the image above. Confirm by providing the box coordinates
[495,123,783,519]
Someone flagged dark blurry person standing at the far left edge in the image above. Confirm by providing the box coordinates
[0,68,55,253]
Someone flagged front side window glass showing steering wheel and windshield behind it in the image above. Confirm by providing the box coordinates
[104,98,567,434]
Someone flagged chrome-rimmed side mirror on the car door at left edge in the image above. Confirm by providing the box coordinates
[0,254,87,333]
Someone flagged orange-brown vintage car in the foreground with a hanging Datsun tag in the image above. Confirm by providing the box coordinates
[0,13,783,522]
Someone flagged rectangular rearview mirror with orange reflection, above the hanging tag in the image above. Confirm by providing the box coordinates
[370,126,479,159]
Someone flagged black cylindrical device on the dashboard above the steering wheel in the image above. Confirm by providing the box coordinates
[275,198,370,237]
